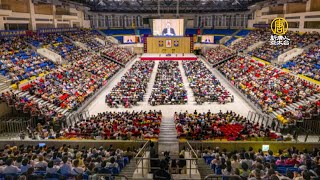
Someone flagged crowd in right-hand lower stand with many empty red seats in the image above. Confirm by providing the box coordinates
[218,57,320,112]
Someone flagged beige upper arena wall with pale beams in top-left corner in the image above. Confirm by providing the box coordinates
[0,0,90,30]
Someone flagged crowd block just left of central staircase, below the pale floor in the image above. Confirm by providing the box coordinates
[58,111,162,140]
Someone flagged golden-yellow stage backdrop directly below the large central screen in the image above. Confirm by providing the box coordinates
[145,37,193,53]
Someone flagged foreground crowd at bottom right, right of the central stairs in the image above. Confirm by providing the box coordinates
[199,147,320,180]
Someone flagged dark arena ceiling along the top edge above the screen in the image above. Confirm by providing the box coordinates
[63,0,263,14]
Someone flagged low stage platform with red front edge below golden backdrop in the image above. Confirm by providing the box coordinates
[140,53,197,61]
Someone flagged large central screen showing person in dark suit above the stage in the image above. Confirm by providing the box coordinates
[153,19,184,36]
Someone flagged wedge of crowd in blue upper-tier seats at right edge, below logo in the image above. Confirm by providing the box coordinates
[282,42,320,81]
